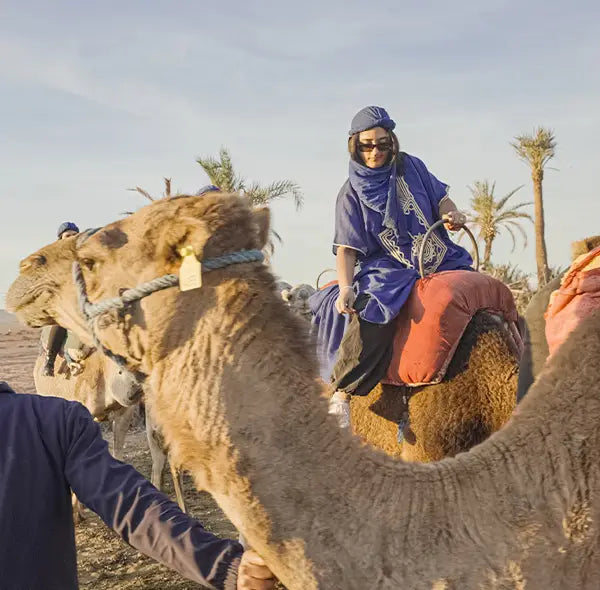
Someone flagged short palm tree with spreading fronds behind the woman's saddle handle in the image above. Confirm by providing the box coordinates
[468,180,533,268]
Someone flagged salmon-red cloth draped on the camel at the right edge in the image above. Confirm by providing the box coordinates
[545,247,600,356]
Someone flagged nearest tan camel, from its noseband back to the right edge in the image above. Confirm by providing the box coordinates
[9,196,600,590]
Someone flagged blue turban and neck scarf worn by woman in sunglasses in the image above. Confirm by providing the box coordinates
[348,106,398,233]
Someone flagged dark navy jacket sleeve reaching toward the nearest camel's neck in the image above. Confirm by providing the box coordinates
[65,404,243,590]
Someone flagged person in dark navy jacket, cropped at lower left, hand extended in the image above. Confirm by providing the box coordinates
[0,381,274,590]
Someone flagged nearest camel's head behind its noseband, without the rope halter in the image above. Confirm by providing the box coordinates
[70,193,274,374]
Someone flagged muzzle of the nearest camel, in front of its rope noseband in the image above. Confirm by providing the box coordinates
[6,234,89,343]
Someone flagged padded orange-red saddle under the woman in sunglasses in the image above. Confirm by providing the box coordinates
[324,270,522,387]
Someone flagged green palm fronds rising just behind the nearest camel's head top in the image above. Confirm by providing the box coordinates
[196,147,303,209]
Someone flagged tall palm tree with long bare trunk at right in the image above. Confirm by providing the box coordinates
[511,127,556,287]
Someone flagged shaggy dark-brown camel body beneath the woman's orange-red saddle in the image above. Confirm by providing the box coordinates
[291,281,519,462]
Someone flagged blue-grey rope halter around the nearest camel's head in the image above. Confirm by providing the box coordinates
[73,250,264,374]
